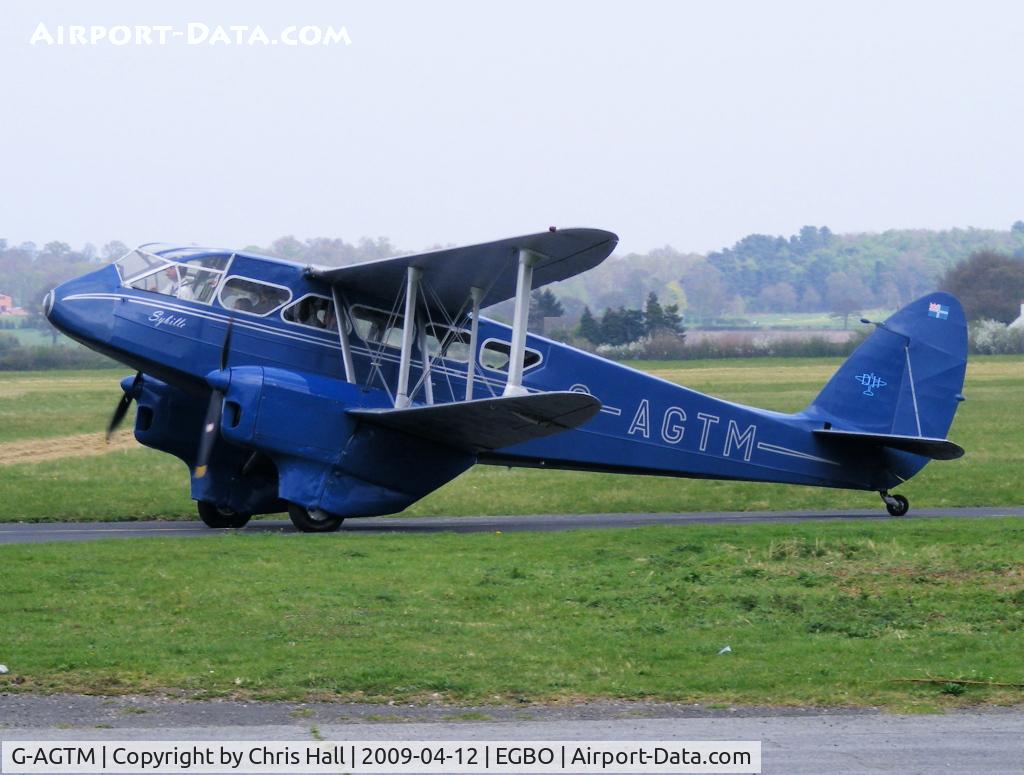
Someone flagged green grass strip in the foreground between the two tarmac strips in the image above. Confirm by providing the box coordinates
[0,520,1024,711]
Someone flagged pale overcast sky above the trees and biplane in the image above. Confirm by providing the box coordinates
[0,0,1024,252]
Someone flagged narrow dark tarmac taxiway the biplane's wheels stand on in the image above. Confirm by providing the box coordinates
[0,502,1024,545]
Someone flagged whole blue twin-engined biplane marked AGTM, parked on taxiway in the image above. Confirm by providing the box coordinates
[45,228,967,531]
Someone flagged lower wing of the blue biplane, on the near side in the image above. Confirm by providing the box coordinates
[348,392,601,453]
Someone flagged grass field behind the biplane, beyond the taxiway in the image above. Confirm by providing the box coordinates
[0,356,1024,521]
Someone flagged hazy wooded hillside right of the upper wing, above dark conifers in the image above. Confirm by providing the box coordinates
[554,221,1024,327]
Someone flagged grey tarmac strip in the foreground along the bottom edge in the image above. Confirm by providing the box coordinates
[0,694,1024,775]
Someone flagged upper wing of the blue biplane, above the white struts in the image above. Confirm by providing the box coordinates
[309,228,618,317]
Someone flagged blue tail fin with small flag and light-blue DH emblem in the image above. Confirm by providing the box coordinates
[804,293,967,439]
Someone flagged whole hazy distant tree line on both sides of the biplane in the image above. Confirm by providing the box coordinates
[6,220,1024,368]
